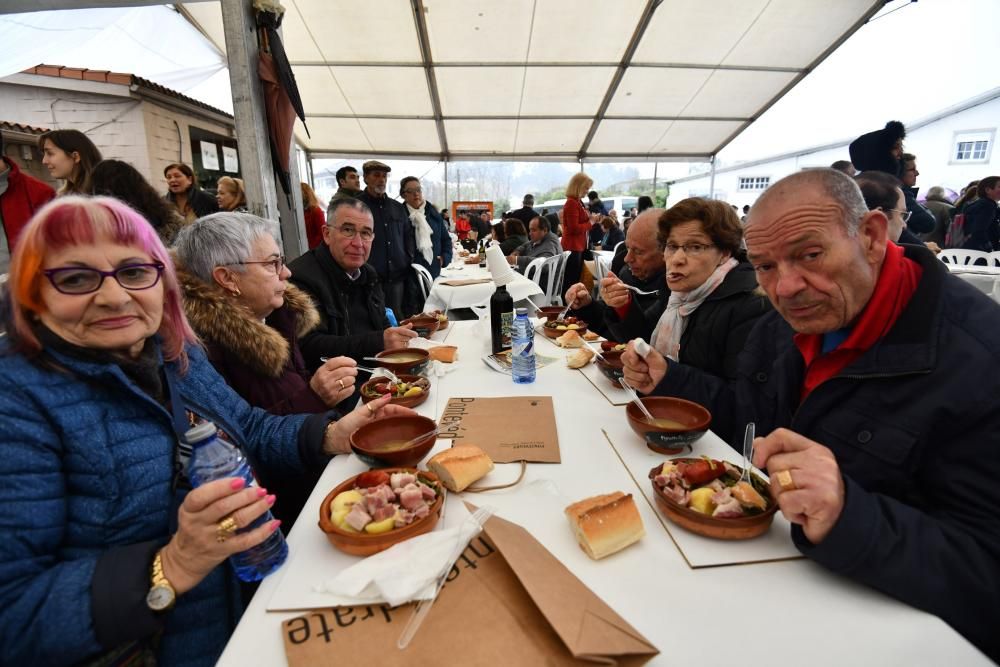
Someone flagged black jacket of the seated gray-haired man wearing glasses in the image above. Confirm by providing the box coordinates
[288,245,389,371]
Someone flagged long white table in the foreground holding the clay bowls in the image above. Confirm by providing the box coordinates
[219,322,990,667]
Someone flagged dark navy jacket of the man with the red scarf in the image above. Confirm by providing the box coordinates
[655,246,1000,661]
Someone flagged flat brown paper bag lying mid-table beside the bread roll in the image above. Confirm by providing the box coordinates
[438,396,560,463]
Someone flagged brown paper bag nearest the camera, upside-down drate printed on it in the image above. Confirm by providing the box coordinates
[281,516,659,667]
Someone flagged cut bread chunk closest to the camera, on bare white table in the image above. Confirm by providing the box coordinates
[566,491,646,560]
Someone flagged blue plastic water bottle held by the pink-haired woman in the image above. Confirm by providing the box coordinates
[184,422,288,581]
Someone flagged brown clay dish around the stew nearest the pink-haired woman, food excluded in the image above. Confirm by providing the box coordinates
[319,468,445,556]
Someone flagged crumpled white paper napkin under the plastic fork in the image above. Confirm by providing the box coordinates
[315,508,493,606]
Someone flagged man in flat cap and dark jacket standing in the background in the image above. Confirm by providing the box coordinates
[358,160,422,320]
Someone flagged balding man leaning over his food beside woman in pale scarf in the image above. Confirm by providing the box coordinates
[566,208,670,343]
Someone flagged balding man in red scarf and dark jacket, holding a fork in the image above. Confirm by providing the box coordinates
[622,169,1000,661]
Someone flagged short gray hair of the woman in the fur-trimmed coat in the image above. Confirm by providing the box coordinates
[174,211,281,283]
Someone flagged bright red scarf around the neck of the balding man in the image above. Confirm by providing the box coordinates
[794,243,923,401]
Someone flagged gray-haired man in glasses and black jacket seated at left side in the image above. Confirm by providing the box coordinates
[288,198,417,370]
